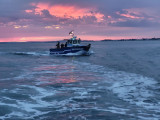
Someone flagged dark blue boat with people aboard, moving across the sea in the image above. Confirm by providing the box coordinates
[50,31,91,56]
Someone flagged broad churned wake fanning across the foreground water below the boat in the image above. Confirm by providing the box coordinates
[0,59,160,120]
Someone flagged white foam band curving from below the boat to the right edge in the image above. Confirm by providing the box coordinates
[74,62,160,112]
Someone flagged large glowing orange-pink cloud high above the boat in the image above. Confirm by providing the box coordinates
[30,3,104,22]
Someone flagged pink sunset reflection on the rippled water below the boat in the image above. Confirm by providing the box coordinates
[32,64,98,85]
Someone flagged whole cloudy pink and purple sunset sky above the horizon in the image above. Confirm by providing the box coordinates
[0,0,160,42]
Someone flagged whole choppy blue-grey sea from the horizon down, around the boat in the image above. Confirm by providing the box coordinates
[0,40,160,120]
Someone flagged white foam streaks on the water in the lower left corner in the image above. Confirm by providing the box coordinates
[0,85,56,119]
